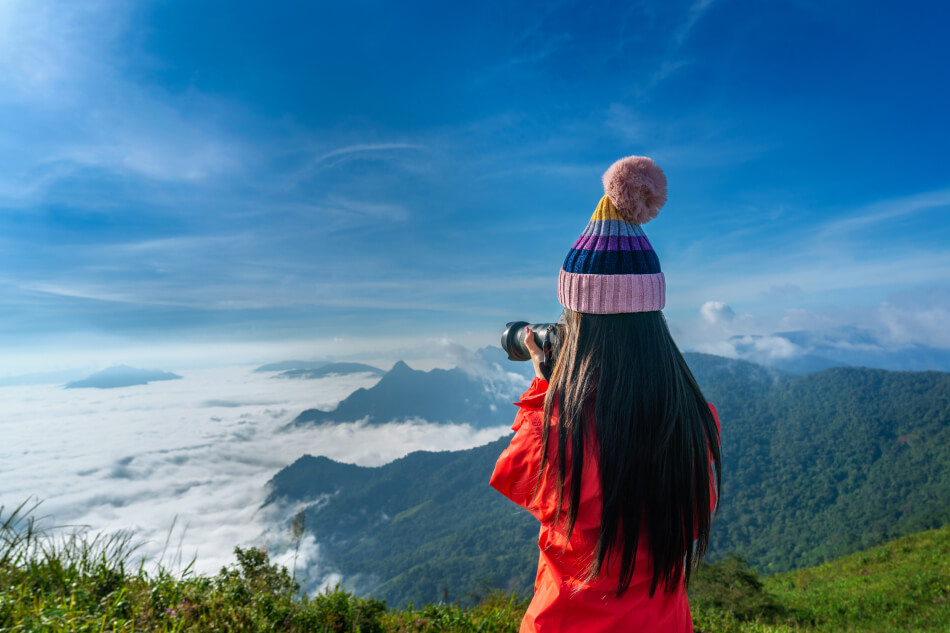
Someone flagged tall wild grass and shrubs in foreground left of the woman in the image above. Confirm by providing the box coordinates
[0,504,527,633]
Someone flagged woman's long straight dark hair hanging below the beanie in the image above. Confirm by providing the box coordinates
[538,310,720,597]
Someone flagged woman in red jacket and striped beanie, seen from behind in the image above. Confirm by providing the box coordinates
[491,156,720,633]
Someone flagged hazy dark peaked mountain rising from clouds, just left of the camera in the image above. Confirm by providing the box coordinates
[291,361,512,427]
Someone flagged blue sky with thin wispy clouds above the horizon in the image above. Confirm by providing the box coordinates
[0,0,950,375]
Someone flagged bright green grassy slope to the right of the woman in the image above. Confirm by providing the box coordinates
[690,526,950,633]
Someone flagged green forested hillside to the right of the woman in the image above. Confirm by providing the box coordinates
[713,367,950,571]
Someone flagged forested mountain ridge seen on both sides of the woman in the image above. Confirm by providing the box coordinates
[269,354,950,604]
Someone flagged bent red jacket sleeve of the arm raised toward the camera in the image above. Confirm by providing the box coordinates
[489,378,548,521]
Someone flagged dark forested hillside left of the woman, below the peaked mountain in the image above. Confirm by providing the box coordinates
[270,438,538,604]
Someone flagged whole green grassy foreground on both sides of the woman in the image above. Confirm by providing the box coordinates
[0,504,950,633]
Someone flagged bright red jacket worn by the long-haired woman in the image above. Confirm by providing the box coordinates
[490,378,719,633]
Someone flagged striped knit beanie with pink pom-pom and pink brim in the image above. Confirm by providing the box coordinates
[557,156,666,314]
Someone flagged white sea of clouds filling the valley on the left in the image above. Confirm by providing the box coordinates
[0,366,509,573]
